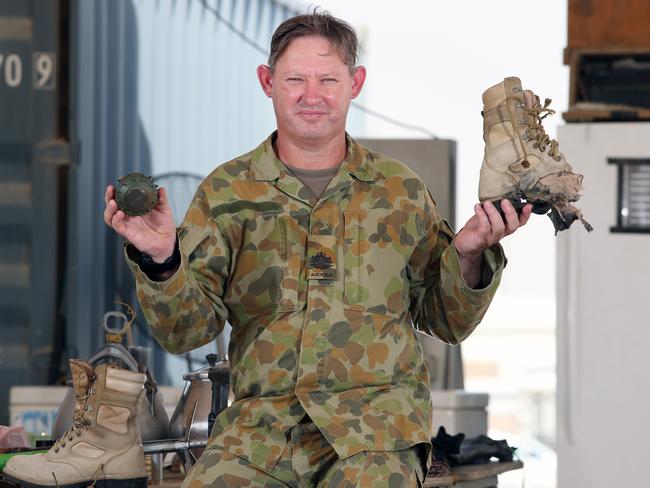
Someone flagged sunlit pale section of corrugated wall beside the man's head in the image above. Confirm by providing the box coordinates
[134,0,282,174]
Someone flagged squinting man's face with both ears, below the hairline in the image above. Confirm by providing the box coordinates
[258,37,365,141]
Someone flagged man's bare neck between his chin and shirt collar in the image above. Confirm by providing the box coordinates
[275,131,347,169]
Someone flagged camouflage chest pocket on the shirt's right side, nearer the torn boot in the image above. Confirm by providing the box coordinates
[343,209,413,316]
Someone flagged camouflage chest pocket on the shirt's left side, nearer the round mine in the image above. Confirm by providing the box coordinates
[228,210,301,312]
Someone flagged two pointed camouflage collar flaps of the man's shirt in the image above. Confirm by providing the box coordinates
[249,131,377,181]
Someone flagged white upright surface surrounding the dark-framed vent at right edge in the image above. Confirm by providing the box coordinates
[557,122,650,488]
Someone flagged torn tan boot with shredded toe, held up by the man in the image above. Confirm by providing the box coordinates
[479,77,593,234]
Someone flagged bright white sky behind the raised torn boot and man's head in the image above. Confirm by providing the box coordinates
[314,0,564,316]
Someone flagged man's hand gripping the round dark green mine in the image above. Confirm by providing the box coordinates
[104,185,176,263]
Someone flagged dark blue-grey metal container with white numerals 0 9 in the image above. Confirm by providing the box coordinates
[0,0,68,424]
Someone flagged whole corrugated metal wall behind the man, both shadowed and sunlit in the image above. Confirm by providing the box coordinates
[67,0,363,382]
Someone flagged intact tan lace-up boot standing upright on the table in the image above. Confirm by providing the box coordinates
[4,359,147,488]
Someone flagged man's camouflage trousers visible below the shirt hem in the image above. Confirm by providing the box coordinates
[182,417,425,488]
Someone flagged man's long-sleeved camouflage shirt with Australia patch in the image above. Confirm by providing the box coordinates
[124,135,505,469]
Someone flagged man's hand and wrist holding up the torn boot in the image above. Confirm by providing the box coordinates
[454,199,533,288]
